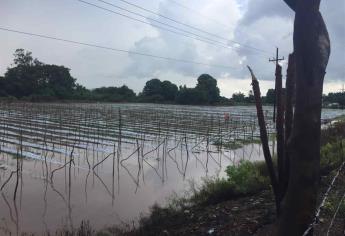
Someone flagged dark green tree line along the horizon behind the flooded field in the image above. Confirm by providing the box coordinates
[0,49,345,106]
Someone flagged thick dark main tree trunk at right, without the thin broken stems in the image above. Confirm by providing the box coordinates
[278,0,330,236]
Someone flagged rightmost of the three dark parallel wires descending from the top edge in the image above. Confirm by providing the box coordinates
[109,0,265,52]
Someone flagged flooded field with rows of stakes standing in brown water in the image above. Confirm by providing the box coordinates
[0,103,345,235]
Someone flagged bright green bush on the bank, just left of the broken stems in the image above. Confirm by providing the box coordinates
[226,161,269,194]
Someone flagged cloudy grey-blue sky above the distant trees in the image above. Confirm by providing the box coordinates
[0,0,345,97]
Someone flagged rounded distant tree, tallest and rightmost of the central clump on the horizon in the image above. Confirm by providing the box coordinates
[195,74,220,104]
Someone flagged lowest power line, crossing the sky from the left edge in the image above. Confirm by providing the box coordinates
[0,27,238,70]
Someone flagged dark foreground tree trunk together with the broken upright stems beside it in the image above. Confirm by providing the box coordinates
[247,0,330,232]
